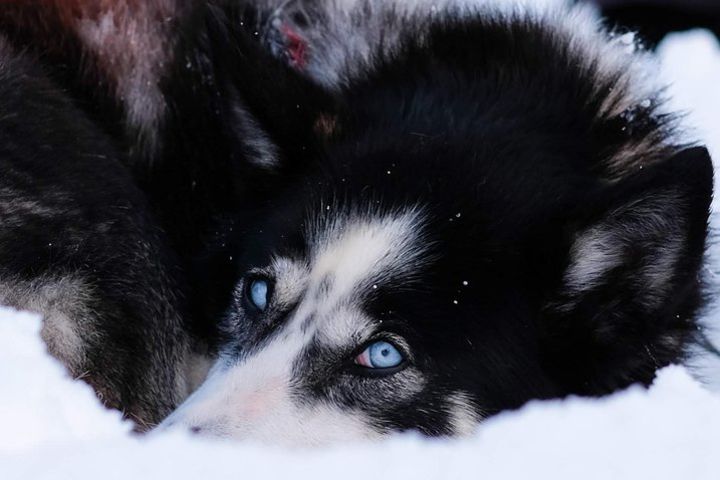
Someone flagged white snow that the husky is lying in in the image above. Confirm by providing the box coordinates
[0,31,720,480]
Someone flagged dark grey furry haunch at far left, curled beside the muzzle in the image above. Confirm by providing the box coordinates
[0,37,189,424]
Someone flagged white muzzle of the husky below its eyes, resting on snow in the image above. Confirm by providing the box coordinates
[161,326,376,446]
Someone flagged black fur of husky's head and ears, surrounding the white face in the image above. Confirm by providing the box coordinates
[0,1,712,434]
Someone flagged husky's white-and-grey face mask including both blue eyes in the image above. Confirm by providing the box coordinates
[170,209,482,444]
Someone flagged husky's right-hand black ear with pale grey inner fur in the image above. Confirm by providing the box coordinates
[543,147,713,394]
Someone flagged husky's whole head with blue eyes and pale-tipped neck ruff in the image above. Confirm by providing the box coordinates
[153,1,713,445]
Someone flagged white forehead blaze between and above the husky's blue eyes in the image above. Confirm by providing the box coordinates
[264,208,427,346]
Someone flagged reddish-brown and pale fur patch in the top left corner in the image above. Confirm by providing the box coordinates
[0,0,186,150]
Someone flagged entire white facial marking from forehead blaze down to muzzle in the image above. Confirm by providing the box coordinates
[163,210,425,446]
